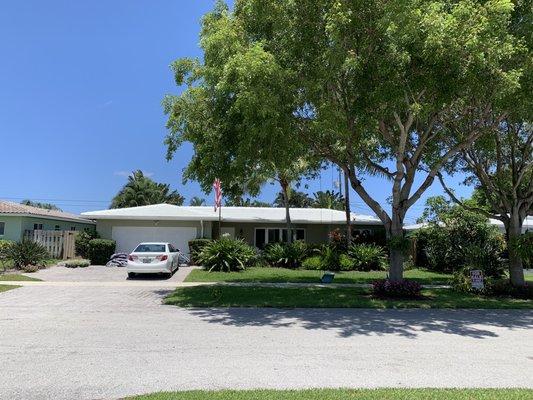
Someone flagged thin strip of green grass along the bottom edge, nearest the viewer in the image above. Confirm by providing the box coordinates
[129,389,533,400]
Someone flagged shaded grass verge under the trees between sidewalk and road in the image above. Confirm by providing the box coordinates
[165,285,533,309]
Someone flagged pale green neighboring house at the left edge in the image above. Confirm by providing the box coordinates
[0,201,94,241]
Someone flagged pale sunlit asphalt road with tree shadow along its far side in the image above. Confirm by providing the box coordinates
[0,282,533,400]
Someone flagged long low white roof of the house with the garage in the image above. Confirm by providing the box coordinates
[82,204,381,225]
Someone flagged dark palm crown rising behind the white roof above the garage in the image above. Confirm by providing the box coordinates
[110,170,185,208]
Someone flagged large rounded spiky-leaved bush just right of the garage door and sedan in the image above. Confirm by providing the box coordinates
[198,237,257,272]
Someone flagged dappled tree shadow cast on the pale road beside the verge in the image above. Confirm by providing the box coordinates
[176,308,533,339]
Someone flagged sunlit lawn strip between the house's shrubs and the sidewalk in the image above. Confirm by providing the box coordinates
[185,267,451,285]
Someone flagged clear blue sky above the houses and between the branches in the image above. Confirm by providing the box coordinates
[0,0,470,221]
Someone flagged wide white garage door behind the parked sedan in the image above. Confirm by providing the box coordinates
[111,226,196,254]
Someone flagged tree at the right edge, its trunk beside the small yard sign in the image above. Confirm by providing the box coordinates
[439,0,533,286]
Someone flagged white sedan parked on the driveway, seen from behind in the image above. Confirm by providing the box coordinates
[126,243,179,278]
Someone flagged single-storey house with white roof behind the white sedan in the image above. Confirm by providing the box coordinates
[82,204,383,252]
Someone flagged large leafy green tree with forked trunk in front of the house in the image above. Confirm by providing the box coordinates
[166,0,522,281]
